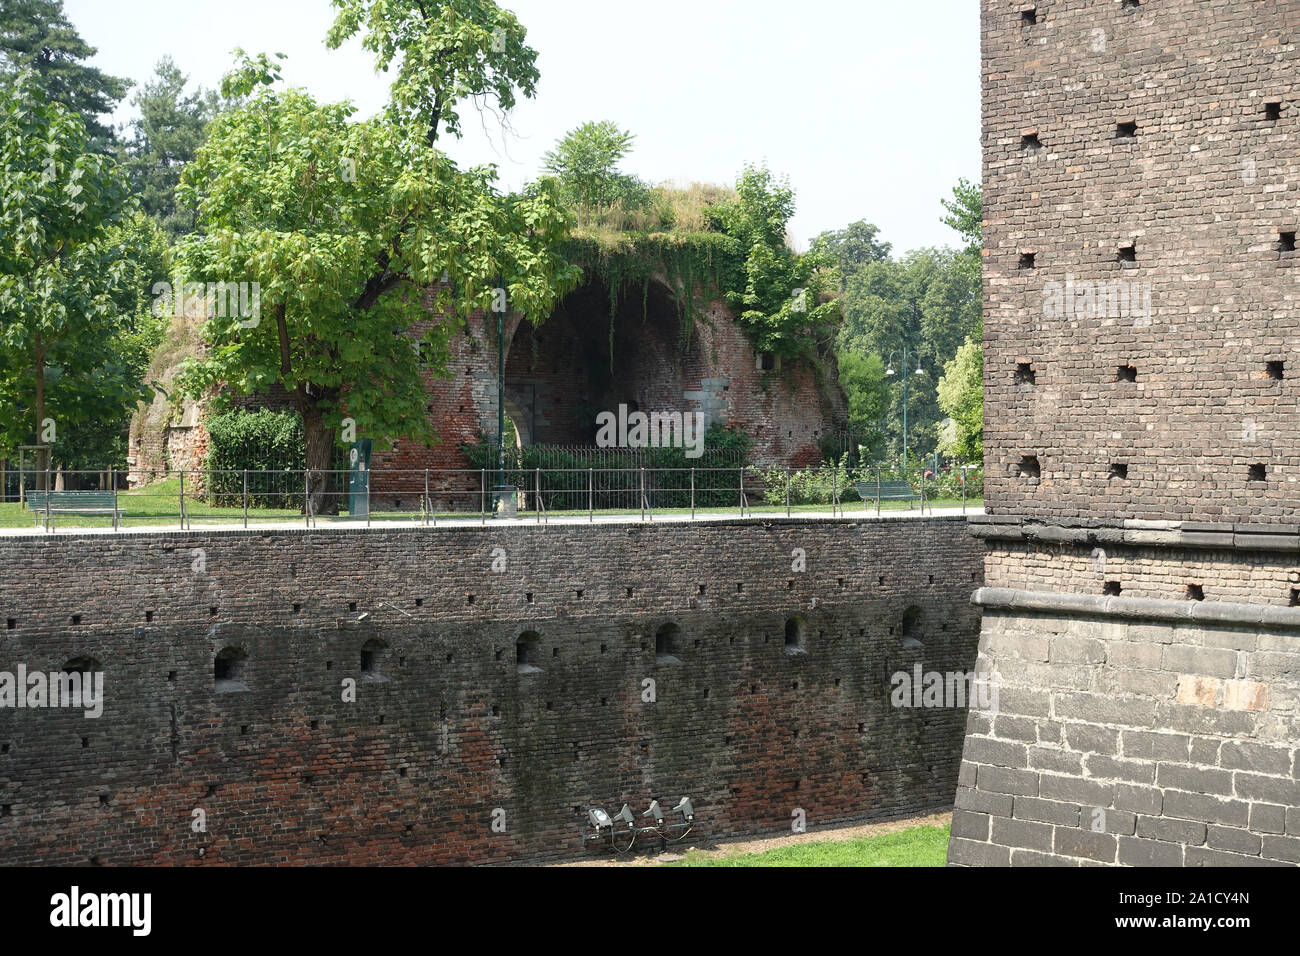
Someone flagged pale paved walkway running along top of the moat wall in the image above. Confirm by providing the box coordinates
[0,507,984,537]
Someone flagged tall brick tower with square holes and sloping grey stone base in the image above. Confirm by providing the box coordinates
[949,0,1300,866]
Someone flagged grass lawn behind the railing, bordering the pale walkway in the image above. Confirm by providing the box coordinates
[0,479,984,529]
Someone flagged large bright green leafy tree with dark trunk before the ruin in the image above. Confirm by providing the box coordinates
[178,57,579,510]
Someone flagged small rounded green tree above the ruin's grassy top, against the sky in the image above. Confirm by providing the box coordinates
[542,120,649,220]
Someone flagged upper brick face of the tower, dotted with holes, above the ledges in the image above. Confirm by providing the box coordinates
[982,0,1300,522]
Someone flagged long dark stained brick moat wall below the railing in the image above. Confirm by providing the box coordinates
[0,518,982,864]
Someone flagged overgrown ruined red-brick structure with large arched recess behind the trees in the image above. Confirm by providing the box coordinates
[131,280,846,510]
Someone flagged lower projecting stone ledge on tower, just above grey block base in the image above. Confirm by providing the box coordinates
[971,588,1300,631]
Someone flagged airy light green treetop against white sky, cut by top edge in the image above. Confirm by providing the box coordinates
[325,0,540,146]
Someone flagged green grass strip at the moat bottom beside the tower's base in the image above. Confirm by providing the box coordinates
[663,826,948,866]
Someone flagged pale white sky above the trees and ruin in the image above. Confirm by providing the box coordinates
[64,0,980,255]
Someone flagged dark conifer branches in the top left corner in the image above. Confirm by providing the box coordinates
[0,0,131,150]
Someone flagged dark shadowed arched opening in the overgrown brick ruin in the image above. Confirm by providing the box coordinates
[506,278,706,445]
